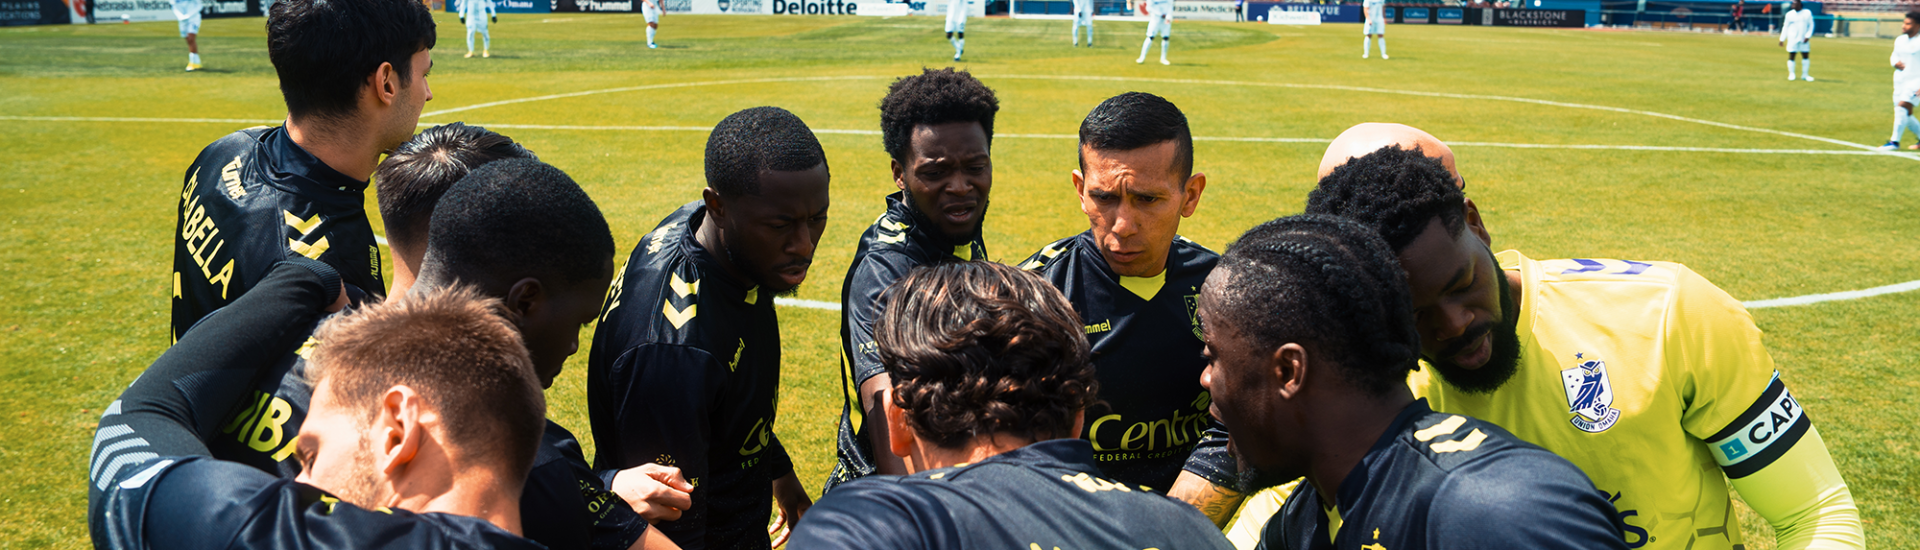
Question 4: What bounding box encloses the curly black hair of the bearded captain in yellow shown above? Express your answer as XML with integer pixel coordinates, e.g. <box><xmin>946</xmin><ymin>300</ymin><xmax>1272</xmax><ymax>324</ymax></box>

<box><xmin>1306</xmin><ymin>146</ymin><xmax>1467</xmax><ymax>254</ymax></box>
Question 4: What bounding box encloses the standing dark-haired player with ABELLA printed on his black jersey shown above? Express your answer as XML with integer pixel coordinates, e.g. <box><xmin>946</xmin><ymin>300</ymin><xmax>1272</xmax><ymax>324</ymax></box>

<box><xmin>173</xmin><ymin>0</ymin><xmax>434</xmax><ymax>338</ymax></box>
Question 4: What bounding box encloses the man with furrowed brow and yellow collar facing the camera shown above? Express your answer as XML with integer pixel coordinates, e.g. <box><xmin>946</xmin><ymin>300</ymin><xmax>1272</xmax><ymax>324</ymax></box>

<box><xmin>1020</xmin><ymin>92</ymin><xmax>1240</xmax><ymax>523</ymax></box>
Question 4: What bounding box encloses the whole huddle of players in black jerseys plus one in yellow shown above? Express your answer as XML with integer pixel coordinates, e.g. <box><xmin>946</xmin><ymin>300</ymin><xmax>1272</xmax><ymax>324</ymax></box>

<box><xmin>88</xmin><ymin>0</ymin><xmax>1864</xmax><ymax>548</ymax></box>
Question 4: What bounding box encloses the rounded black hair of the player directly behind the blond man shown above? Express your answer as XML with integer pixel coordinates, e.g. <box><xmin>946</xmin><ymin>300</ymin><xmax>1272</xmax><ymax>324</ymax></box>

<box><xmin>420</xmin><ymin>158</ymin><xmax>612</xmax><ymax>285</ymax></box>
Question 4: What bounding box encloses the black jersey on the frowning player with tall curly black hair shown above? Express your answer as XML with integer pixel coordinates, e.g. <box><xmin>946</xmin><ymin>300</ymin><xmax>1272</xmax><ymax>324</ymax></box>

<box><xmin>822</xmin><ymin>190</ymin><xmax>987</xmax><ymax>490</ymax></box>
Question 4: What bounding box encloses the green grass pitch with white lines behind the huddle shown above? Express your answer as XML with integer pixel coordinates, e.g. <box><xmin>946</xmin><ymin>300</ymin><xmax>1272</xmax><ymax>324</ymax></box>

<box><xmin>0</xmin><ymin>13</ymin><xmax>1920</xmax><ymax>548</ymax></box>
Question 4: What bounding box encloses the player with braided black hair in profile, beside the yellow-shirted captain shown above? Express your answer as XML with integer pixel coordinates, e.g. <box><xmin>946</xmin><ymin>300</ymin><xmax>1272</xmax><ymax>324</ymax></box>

<box><xmin>1198</xmin><ymin>215</ymin><xmax>1626</xmax><ymax>550</ymax></box>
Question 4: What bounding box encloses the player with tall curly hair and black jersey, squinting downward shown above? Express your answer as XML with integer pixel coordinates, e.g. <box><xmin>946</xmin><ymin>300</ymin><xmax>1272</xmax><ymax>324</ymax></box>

<box><xmin>824</xmin><ymin>67</ymin><xmax>1000</xmax><ymax>490</ymax></box>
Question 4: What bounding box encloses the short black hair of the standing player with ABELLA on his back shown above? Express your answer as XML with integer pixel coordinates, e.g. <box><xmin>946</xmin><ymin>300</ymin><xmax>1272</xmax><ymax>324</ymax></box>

<box><xmin>267</xmin><ymin>0</ymin><xmax>434</xmax><ymax>119</ymax></box>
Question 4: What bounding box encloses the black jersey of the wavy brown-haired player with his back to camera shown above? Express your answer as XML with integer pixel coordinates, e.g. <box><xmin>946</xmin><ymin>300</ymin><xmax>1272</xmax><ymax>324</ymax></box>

<box><xmin>789</xmin><ymin>438</ymin><xmax>1233</xmax><ymax>550</ymax></box>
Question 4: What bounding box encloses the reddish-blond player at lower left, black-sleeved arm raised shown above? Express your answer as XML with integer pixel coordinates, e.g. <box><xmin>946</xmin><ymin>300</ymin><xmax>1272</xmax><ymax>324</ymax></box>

<box><xmin>88</xmin><ymin>256</ymin><xmax>545</xmax><ymax>550</ymax></box>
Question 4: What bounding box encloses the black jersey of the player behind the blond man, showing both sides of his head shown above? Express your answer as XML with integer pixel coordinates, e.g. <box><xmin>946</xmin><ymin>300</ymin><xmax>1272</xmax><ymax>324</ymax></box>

<box><xmin>201</xmin><ymin>323</ymin><xmax>647</xmax><ymax>550</ymax></box>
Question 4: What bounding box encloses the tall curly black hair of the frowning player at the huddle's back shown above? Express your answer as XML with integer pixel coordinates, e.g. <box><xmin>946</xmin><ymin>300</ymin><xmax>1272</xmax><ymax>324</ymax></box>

<box><xmin>879</xmin><ymin>67</ymin><xmax>1000</xmax><ymax>163</ymax></box>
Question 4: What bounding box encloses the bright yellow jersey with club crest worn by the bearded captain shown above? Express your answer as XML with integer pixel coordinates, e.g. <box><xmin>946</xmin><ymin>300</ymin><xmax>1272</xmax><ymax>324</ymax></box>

<box><xmin>1409</xmin><ymin>250</ymin><xmax>1804</xmax><ymax>550</ymax></box>
